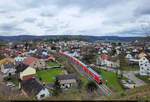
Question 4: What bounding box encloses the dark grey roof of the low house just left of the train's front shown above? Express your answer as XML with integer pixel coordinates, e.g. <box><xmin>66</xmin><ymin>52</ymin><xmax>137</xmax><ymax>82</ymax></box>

<box><xmin>56</xmin><ymin>73</ymin><xmax>77</xmax><ymax>80</ymax></box>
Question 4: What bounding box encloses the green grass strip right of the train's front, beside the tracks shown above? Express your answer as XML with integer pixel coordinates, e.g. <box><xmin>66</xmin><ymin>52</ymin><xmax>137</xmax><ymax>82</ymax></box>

<box><xmin>100</xmin><ymin>69</ymin><xmax>123</xmax><ymax>91</ymax></box>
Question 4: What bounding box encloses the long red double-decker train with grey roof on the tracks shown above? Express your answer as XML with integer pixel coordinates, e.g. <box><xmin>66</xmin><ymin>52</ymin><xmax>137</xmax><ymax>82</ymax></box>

<box><xmin>60</xmin><ymin>52</ymin><xmax>103</xmax><ymax>84</ymax></box>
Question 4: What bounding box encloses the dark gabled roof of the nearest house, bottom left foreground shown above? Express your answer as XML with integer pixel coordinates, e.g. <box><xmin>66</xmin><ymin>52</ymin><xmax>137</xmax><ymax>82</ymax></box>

<box><xmin>21</xmin><ymin>78</ymin><xmax>44</xmax><ymax>95</ymax></box>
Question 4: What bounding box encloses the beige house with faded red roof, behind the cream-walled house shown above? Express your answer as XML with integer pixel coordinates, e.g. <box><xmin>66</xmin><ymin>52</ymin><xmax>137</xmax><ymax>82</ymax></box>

<box><xmin>23</xmin><ymin>56</ymin><xmax>46</xmax><ymax>69</ymax></box>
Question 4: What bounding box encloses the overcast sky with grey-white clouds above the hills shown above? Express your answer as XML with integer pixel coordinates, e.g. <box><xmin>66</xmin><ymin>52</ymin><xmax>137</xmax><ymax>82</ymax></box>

<box><xmin>0</xmin><ymin>0</ymin><xmax>150</xmax><ymax>36</ymax></box>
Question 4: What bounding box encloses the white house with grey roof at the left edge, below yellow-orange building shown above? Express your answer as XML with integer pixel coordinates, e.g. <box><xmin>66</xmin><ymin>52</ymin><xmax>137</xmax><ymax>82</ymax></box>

<box><xmin>1</xmin><ymin>62</ymin><xmax>16</xmax><ymax>74</ymax></box>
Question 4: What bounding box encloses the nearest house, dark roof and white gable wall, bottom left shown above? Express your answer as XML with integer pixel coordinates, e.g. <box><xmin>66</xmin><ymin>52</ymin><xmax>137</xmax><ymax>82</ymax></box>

<box><xmin>21</xmin><ymin>78</ymin><xmax>50</xmax><ymax>100</ymax></box>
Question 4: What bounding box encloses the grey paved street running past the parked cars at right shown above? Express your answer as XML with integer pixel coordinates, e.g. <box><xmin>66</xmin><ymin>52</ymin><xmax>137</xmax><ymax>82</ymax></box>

<box><xmin>97</xmin><ymin>66</ymin><xmax>146</xmax><ymax>86</ymax></box>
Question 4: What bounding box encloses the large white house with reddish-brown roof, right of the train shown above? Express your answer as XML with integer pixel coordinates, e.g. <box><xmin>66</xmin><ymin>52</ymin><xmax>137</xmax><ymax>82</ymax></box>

<box><xmin>97</xmin><ymin>55</ymin><xmax>119</xmax><ymax>68</ymax></box>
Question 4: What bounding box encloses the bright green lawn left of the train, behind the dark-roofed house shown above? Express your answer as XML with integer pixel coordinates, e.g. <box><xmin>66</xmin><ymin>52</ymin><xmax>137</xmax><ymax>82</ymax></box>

<box><xmin>37</xmin><ymin>68</ymin><xmax>62</xmax><ymax>82</ymax></box>
